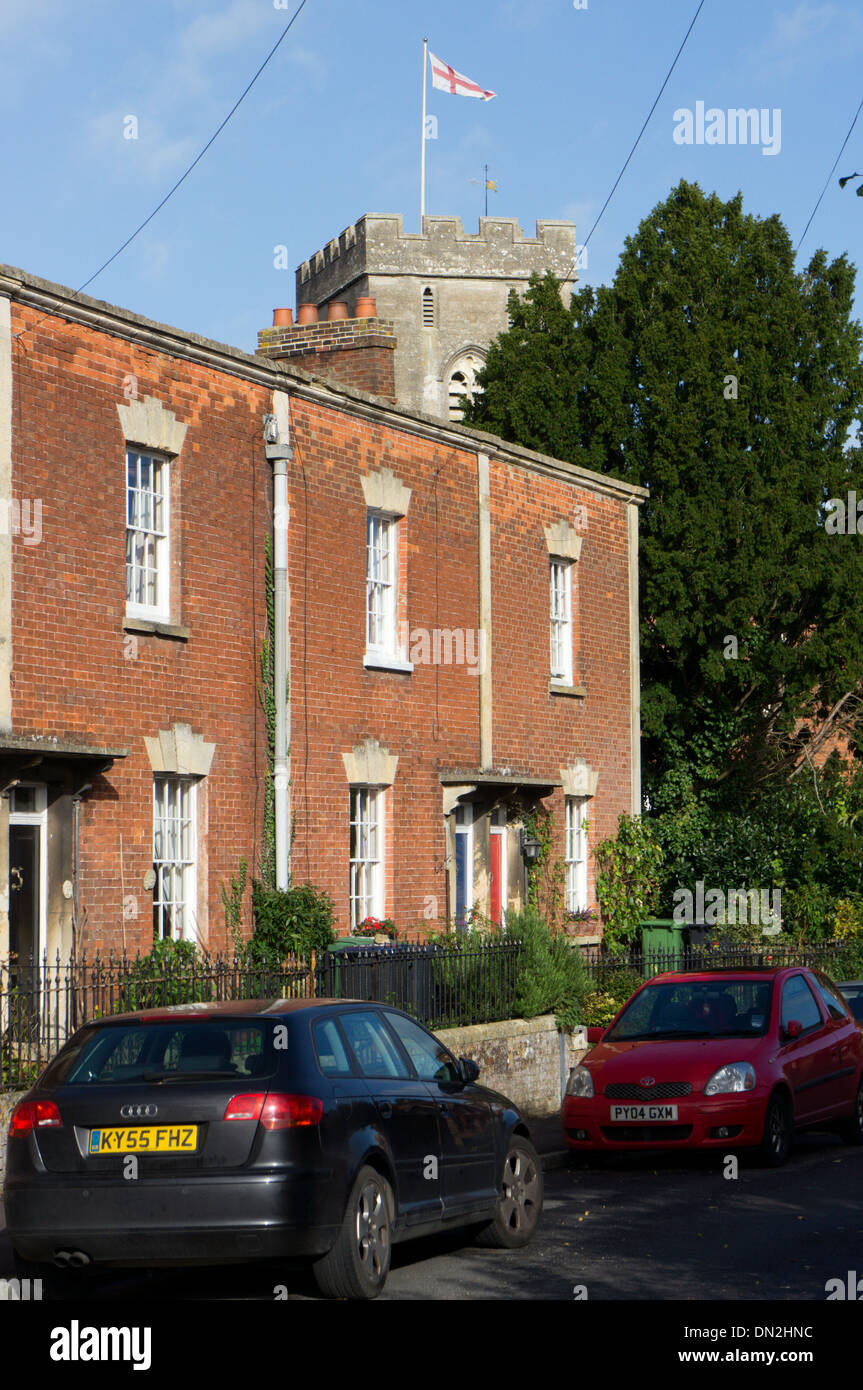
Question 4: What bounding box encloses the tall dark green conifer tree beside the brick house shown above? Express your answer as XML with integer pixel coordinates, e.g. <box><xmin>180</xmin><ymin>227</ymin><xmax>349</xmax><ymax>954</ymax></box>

<box><xmin>466</xmin><ymin>182</ymin><xmax>863</xmax><ymax>809</ymax></box>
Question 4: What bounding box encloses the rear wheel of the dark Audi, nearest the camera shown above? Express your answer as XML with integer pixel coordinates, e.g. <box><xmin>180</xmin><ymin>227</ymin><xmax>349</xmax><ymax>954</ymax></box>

<box><xmin>313</xmin><ymin>1165</ymin><xmax>395</xmax><ymax>1298</ymax></box>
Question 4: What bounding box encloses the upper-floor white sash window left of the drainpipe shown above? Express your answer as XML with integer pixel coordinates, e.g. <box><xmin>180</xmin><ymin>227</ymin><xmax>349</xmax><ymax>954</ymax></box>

<box><xmin>125</xmin><ymin>448</ymin><xmax>171</xmax><ymax>621</ymax></box>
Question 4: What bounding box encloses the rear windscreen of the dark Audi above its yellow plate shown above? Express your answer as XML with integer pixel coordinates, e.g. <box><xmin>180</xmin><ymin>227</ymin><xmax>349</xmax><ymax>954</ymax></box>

<box><xmin>43</xmin><ymin>1019</ymin><xmax>283</xmax><ymax>1086</ymax></box>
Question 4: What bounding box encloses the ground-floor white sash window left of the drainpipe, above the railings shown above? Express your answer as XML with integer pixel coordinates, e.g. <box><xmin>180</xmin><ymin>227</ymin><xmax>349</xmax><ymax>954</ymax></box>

<box><xmin>153</xmin><ymin>773</ymin><xmax>197</xmax><ymax>941</ymax></box>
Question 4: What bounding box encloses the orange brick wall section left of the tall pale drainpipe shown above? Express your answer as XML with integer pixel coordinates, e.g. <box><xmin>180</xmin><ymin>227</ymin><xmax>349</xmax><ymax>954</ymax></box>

<box><xmin>13</xmin><ymin>304</ymin><xmax>272</xmax><ymax>952</ymax></box>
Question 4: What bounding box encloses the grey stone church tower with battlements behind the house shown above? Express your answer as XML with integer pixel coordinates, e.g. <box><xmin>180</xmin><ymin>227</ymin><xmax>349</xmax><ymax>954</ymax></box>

<box><xmin>296</xmin><ymin>213</ymin><xmax>577</xmax><ymax>420</ymax></box>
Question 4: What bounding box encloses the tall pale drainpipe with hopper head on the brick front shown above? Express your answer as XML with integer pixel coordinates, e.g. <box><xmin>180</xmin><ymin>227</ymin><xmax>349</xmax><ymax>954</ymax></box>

<box><xmin>264</xmin><ymin>391</ymin><xmax>293</xmax><ymax>890</ymax></box>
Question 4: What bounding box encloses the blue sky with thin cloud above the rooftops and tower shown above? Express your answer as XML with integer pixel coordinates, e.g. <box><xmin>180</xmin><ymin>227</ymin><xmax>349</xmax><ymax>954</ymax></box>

<box><xmin>0</xmin><ymin>0</ymin><xmax>863</xmax><ymax>350</ymax></box>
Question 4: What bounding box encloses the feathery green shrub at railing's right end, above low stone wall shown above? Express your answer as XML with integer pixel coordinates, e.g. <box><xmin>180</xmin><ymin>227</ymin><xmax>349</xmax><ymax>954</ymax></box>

<box><xmin>506</xmin><ymin>908</ymin><xmax>588</xmax><ymax>1030</ymax></box>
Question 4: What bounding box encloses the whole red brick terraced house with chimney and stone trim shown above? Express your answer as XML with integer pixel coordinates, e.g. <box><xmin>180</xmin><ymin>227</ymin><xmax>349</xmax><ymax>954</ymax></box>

<box><xmin>0</xmin><ymin>267</ymin><xmax>643</xmax><ymax>956</ymax></box>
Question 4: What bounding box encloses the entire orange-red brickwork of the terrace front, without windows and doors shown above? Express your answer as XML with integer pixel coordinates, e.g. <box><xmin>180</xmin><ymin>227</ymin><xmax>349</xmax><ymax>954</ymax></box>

<box><xmin>1</xmin><ymin>265</ymin><xmax>631</xmax><ymax>952</ymax></box>
